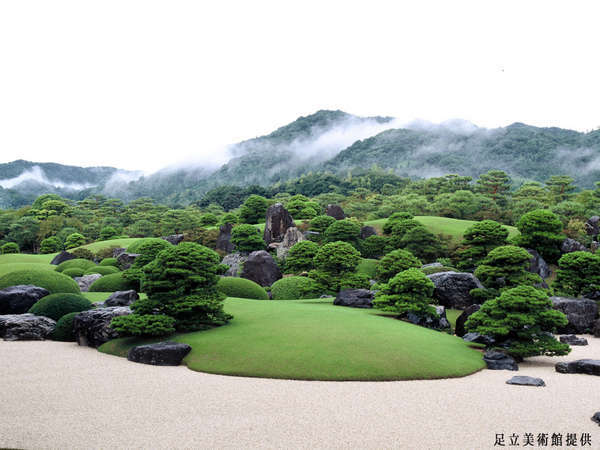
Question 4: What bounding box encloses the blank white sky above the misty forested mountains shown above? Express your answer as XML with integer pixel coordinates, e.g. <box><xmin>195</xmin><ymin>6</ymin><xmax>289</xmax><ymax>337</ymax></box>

<box><xmin>0</xmin><ymin>0</ymin><xmax>600</xmax><ymax>171</ymax></box>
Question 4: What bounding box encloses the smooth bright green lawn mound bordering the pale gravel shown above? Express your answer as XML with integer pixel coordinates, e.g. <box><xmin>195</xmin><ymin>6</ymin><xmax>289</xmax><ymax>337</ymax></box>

<box><xmin>99</xmin><ymin>298</ymin><xmax>484</xmax><ymax>381</ymax></box>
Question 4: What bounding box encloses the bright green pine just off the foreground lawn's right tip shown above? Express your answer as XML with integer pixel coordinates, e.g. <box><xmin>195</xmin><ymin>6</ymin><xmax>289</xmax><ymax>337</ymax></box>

<box><xmin>465</xmin><ymin>286</ymin><xmax>571</xmax><ymax>358</ymax></box>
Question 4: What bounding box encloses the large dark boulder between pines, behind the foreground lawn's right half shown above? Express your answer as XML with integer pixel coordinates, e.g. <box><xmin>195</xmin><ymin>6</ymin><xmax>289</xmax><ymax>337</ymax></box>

<box><xmin>427</xmin><ymin>272</ymin><xmax>483</xmax><ymax>309</ymax></box>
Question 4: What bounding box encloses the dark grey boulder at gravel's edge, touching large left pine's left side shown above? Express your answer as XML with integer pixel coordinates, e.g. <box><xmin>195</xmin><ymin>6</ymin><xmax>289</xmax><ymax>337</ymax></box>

<box><xmin>73</xmin><ymin>306</ymin><xmax>131</xmax><ymax>347</ymax></box>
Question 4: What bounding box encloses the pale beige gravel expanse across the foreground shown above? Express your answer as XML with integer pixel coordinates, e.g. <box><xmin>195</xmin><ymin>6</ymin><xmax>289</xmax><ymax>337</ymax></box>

<box><xmin>0</xmin><ymin>336</ymin><xmax>600</xmax><ymax>449</ymax></box>
